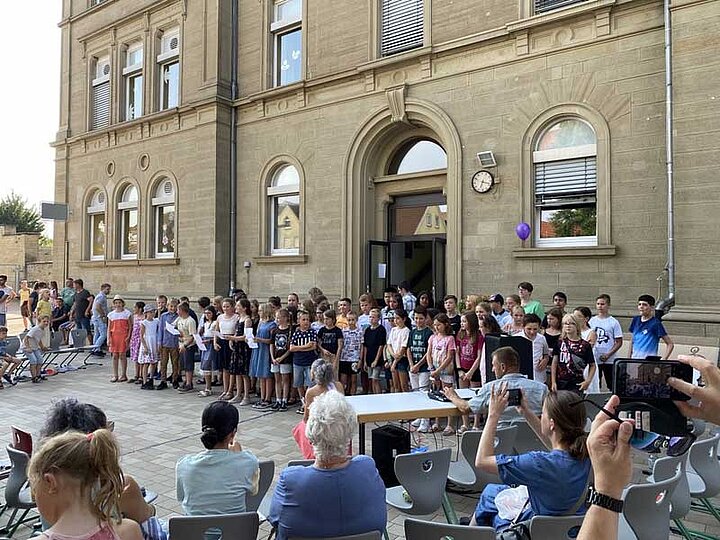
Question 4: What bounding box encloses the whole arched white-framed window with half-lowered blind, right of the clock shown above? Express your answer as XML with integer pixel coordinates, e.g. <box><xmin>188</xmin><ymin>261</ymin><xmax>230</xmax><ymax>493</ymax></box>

<box><xmin>532</xmin><ymin>117</ymin><xmax>598</xmax><ymax>247</ymax></box>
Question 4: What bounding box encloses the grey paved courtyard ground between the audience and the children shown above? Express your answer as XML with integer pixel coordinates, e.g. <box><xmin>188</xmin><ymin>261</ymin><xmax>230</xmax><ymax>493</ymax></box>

<box><xmin>0</xmin><ymin>310</ymin><xmax>720</xmax><ymax>540</ymax></box>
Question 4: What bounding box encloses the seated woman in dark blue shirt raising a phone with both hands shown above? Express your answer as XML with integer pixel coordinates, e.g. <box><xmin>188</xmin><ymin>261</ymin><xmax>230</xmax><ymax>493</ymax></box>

<box><xmin>471</xmin><ymin>385</ymin><xmax>590</xmax><ymax>530</ymax></box>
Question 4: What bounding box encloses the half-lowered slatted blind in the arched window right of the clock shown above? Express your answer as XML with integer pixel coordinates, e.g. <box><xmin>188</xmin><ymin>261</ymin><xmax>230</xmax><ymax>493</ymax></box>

<box><xmin>535</xmin><ymin>157</ymin><xmax>597</xmax><ymax>206</ymax></box>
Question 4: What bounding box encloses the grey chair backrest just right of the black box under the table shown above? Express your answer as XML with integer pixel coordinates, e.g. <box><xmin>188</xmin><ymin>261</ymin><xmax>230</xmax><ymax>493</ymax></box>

<box><xmin>395</xmin><ymin>448</ymin><xmax>452</xmax><ymax>515</ymax></box>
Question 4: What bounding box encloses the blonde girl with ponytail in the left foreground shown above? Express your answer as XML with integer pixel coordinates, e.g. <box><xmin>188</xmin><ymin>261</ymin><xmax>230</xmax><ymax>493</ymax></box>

<box><xmin>28</xmin><ymin>429</ymin><xmax>142</xmax><ymax>540</ymax></box>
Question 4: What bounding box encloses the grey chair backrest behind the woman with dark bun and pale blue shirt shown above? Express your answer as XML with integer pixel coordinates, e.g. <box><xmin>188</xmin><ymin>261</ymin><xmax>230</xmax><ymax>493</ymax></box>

<box><xmin>169</xmin><ymin>512</ymin><xmax>260</xmax><ymax>540</ymax></box>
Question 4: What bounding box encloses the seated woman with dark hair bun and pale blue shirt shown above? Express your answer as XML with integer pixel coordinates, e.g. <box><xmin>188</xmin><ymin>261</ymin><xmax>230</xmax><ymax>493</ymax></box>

<box><xmin>175</xmin><ymin>401</ymin><xmax>260</xmax><ymax>516</ymax></box>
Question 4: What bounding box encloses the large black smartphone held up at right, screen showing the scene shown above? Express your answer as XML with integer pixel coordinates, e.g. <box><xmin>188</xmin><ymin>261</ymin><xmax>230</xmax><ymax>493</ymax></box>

<box><xmin>613</xmin><ymin>358</ymin><xmax>693</xmax><ymax>401</ymax></box>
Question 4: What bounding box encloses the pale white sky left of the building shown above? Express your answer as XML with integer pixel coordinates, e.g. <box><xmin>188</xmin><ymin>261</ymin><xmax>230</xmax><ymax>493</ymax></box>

<box><xmin>0</xmin><ymin>0</ymin><xmax>62</xmax><ymax>236</ymax></box>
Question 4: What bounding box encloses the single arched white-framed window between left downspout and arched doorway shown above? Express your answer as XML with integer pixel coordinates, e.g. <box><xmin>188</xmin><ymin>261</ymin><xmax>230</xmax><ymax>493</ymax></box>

<box><xmin>267</xmin><ymin>165</ymin><xmax>300</xmax><ymax>255</ymax></box>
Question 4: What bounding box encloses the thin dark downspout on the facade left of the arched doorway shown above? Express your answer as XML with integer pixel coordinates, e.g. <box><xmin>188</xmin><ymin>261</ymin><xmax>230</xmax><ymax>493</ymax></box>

<box><xmin>228</xmin><ymin>0</ymin><xmax>238</xmax><ymax>296</ymax></box>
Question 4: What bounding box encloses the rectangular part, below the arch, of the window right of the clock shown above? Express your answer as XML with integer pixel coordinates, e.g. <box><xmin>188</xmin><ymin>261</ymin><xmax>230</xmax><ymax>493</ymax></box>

<box><xmin>535</xmin><ymin>156</ymin><xmax>597</xmax><ymax>247</ymax></box>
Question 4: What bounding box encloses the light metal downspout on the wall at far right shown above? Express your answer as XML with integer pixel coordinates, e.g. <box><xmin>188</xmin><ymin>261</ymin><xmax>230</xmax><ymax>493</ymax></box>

<box><xmin>656</xmin><ymin>0</ymin><xmax>675</xmax><ymax>313</ymax></box>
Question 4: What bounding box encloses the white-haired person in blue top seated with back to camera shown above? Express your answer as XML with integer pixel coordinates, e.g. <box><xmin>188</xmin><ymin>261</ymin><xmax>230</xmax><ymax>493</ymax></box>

<box><xmin>268</xmin><ymin>392</ymin><xmax>387</xmax><ymax>540</ymax></box>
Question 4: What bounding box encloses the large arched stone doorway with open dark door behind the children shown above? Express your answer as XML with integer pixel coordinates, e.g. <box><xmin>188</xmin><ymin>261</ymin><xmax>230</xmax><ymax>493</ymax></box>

<box><xmin>341</xmin><ymin>97</ymin><xmax>462</xmax><ymax>297</ymax></box>
